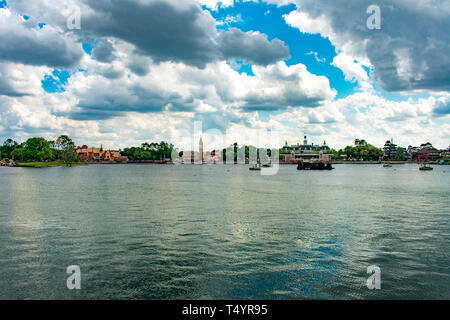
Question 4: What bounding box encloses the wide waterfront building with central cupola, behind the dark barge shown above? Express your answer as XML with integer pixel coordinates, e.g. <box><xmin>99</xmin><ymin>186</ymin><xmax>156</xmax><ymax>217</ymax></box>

<box><xmin>280</xmin><ymin>136</ymin><xmax>331</xmax><ymax>163</ymax></box>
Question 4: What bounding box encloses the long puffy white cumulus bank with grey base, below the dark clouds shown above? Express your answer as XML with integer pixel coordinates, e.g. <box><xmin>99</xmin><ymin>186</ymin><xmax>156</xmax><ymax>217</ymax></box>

<box><xmin>64</xmin><ymin>56</ymin><xmax>335</xmax><ymax>119</ymax></box>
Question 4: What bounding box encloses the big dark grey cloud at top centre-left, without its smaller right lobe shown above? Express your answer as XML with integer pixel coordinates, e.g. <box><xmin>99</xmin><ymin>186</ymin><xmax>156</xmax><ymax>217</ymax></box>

<box><xmin>82</xmin><ymin>0</ymin><xmax>219</xmax><ymax>67</ymax></box>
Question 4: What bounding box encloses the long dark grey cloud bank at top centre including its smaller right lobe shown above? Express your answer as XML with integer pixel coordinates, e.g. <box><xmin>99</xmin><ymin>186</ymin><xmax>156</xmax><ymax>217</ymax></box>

<box><xmin>82</xmin><ymin>0</ymin><xmax>289</xmax><ymax>67</ymax></box>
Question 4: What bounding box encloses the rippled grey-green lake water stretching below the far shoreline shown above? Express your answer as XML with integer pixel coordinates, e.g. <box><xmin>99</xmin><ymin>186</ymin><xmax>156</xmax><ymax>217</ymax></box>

<box><xmin>0</xmin><ymin>165</ymin><xmax>450</xmax><ymax>299</ymax></box>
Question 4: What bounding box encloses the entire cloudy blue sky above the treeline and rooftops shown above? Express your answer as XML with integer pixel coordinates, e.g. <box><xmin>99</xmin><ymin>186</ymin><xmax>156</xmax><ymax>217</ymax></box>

<box><xmin>0</xmin><ymin>0</ymin><xmax>450</xmax><ymax>150</ymax></box>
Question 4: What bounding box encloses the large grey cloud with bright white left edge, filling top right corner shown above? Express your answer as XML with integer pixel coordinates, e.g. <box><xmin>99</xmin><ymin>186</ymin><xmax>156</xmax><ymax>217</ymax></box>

<box><xmin>285</xmin><ymin>0</ymin><xmax>450</xmax><ymax>91</ymax></box>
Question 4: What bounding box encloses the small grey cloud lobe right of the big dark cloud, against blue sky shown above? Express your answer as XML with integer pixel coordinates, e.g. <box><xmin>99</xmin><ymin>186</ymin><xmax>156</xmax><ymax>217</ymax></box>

<box><xmin>219</xmin><ymin>28</ymin><xmax>289</xmax><ymax>66</ymax></box>
